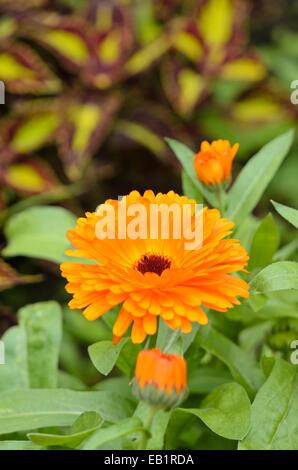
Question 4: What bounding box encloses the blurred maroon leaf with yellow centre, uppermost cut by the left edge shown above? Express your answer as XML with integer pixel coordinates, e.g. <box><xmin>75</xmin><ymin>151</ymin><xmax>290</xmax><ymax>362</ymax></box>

<box><xmin>0</xmin><ymin>43</ymin><xmax>60</xmax><ymax>94</ymax></box>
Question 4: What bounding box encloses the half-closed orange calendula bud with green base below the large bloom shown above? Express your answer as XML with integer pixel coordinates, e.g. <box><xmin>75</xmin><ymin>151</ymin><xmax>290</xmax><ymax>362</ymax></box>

<box><xmin>133</xmin><ymin>349</ymin><xmax>187</xmax><ymax>407</ymax></box>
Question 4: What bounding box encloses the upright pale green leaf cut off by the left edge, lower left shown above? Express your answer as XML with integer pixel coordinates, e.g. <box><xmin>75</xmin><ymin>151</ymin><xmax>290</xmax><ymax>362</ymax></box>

<box><xmin>0</xmin><ymin>326</ymin><xmax>29</xmax><ymax>392</ymax></box>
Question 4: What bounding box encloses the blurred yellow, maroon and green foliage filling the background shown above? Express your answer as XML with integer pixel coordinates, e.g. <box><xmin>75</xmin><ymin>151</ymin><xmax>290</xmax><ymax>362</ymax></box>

<box><xmin>0</xmin><ymin>0</ymin><xmax>298</xmax><ymax>418</ymax></box>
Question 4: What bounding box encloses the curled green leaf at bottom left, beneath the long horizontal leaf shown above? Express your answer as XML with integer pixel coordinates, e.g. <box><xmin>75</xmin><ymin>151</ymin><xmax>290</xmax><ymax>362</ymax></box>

<box><xmin>28</xmin><ymin>411</ymin><xmax>103</xmax><ymax>448</ymax></box>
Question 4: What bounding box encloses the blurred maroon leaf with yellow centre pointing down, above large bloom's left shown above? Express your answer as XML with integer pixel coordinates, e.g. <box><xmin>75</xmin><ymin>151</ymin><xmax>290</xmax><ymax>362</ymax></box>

<box><xmin>57</xmin><ymin>94</ymin><xmax>119</xmax><ymax>179</ymax></box>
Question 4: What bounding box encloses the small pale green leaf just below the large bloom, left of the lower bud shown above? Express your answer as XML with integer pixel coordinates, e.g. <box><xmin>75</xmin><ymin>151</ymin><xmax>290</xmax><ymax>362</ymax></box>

<box><xmin>88</xmin><ymin>338</ymin><xmax>128</xmax><ymax>375</ymax></box>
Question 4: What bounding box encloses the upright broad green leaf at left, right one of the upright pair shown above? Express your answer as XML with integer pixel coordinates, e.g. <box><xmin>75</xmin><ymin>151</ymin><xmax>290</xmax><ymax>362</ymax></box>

<box><xmin>19</xmin><ymin>302</ymin><xmax>62</xmax><ymax>388</ymax></box>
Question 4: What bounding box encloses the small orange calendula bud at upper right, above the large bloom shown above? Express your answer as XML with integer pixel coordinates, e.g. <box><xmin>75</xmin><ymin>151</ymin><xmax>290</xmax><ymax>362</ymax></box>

<box><xmin>194</xmin><ymin>139</ymin><xmax>239</xmax><ymax>185</ymax></box>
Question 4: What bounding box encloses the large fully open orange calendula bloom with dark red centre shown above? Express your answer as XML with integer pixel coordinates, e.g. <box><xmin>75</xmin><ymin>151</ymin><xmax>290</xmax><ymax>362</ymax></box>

<box><xmin>61</xmin><ymin>191</ymin><xmax>248</xmax><ymax>343</ymax></box>
